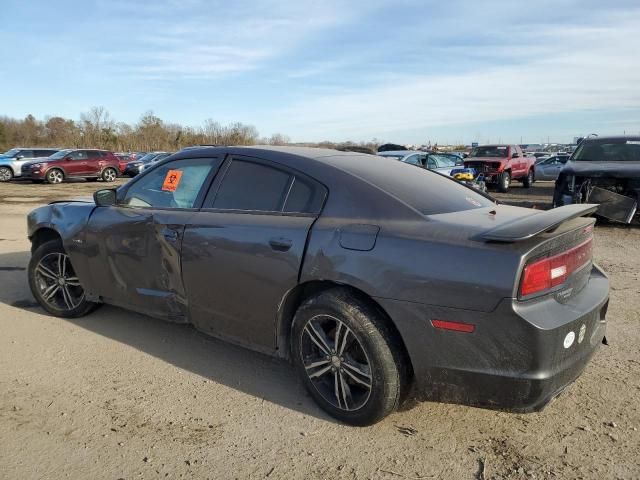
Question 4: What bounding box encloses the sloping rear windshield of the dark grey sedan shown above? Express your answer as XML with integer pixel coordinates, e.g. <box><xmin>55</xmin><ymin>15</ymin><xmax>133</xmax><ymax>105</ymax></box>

<box><xmin>333</xmin><ymin>156</ymin><xmax>495</xmax><ymax>215</ymax></box>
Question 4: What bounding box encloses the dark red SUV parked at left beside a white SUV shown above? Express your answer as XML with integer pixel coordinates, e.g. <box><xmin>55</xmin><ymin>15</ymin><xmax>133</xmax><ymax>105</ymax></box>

<box><xmin>22</xmin><ymin>149</ymin><xmax>120</xmax><ymax>183</ymax></box>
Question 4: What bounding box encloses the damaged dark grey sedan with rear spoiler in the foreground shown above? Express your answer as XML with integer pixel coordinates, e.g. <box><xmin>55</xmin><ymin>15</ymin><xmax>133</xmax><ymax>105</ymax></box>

<box><xmin>28</xmin><ymin>147</ymin><xmax>609</xmax><ymax>425</ymax></box>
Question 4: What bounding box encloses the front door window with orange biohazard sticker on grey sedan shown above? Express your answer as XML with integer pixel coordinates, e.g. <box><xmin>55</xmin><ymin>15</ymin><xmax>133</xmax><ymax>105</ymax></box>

<box><xmin>121</xmin><ymin>158</ymin><xmax>220</xmax><ymax>208</ymax></box>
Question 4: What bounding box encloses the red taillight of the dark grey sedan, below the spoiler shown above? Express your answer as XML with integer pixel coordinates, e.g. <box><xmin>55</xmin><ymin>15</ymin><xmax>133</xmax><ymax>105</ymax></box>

<box><xmin>520</xmin><ymin>238</ymin><xmax>593</xmax><ymax>297</ymax></box>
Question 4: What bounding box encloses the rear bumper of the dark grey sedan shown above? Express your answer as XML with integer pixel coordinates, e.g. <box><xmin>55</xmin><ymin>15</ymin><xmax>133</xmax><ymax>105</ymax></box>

<box><xmin>379</xmin><ymin>266</ymin><xmax>609</xmax><ymax>412</ymax></box>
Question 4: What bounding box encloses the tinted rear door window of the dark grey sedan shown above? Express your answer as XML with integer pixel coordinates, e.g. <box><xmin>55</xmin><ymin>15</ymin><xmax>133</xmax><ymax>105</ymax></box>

<box><xmin>212</xmin><ymin>159</ymin><xmax>326</xmax><ymax>214</ymax></box>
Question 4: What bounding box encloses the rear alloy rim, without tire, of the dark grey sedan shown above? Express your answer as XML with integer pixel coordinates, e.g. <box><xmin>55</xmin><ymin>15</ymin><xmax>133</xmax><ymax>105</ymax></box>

<box><xmin>300</xmin><ymin>315</ymin><xmax>372</xmax><ymax>411</ymax></box>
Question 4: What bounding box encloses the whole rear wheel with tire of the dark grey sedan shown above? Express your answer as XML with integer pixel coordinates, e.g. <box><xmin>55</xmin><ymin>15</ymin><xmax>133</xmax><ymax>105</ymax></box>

<box><xmin>291</xmin><ymin>289</ymin><xmax>408</xmax><ymax>426</ymax></box>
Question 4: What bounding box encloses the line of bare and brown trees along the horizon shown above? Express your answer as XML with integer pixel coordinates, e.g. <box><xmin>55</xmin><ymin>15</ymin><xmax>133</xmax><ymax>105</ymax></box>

<box><xmin>0</xmin><ymin>107</ymin><xmax>378</xmax><ymax>152</ymax></box>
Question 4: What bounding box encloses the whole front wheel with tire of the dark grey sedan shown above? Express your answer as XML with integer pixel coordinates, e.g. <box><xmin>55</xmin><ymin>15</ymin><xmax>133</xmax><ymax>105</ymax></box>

<box><xmin>28</xmin><ymin>240</ymin><xmax>97</xmax><ymax>318</ymax></box>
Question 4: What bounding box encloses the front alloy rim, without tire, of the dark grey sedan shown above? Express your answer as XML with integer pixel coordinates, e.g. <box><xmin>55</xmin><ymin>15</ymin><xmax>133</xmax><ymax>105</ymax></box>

<box><xmin>35</xmin><ymin>253</ymin><xmax>84</xmax><ymax>310</ymax></box>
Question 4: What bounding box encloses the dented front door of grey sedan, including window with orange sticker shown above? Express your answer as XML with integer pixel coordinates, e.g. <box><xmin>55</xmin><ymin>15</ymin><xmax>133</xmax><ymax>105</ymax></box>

<box><xmin>86</xmin><ymin>158</ymin><xmax>219</xmax><ymax>322</ymax></box>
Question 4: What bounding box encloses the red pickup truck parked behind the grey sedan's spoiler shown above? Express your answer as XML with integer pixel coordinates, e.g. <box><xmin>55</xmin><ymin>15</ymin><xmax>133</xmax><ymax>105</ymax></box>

<box><xmin>464</xmin><ymin>145</ymin><xmax>536</xmax><ymax>193</ymax></box>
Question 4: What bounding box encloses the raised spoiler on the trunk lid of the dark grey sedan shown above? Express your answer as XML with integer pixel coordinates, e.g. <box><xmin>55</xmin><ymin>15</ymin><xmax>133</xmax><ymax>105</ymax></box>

<box><xmin>476</xmin><ymin>203</ymin><xmax>598</xmax><ymax>242</ymax></box>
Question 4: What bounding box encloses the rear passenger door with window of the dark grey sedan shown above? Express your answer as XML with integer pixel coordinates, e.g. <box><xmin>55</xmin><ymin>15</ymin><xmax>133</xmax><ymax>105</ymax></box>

<box><xmin>182</xmin><ymin>155</ymin><xmax>327</xmax><ymax>351</ymax></box>
